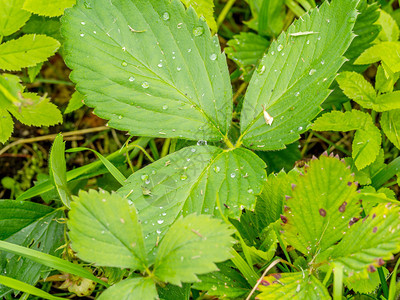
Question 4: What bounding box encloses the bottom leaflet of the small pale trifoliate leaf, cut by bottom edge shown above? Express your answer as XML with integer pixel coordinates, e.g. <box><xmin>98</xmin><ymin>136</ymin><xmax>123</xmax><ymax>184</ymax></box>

<box><xmin>98</xmin><ymin>277</ymin><xmax>158</xmax><ymax>300</ymax></box>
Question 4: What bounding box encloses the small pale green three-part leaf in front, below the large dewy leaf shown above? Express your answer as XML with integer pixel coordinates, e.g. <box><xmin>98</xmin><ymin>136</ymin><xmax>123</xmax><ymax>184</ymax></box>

<box><xmin>68</xmin><ymin>190</ymin><xmax>233</xmax><ymax>299</ymax></box>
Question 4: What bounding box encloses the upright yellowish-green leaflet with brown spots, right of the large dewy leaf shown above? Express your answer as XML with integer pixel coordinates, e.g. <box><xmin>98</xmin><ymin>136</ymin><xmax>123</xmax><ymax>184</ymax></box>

<box><xmin>281</xmin><ymin>156</ymin><xmax>361</xmax><ymax>256</ymax></box>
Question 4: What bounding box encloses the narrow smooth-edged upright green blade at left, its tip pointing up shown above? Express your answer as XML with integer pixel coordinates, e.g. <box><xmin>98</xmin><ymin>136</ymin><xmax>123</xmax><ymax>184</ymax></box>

<box><xmin>49</xmin><ymin>134</ymin><xmax>72</xmax><ymax>208</ymax></box>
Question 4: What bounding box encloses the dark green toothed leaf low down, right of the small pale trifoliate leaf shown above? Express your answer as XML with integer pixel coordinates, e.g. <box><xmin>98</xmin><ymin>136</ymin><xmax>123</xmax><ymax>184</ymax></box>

<box><xmin>192</xmin><ymin>261</ymin><xmax>251</xmax><ymax>298</ymax></box>
